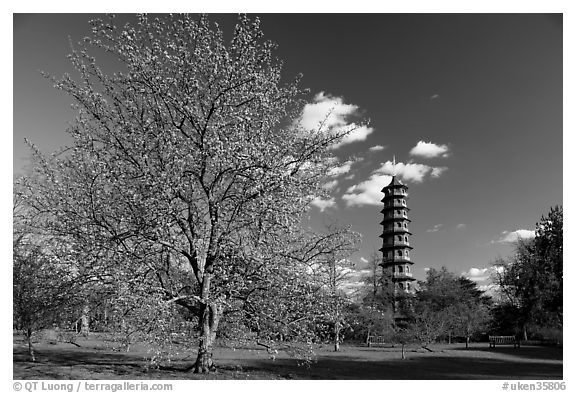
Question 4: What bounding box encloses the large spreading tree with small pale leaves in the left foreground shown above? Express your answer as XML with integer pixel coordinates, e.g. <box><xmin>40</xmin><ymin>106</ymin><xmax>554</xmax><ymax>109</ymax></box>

<box><xmin>19</xmin><ymin>15</ymin><xmax>360</xmax><ymax>372</ymax></box>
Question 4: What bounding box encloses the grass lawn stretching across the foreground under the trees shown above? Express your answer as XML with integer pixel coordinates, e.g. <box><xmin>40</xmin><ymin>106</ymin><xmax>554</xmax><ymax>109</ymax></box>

<box><xmin>13</xmin><ymin>339</ymin><xmax>563</xmax><ymax>380</ymax></box>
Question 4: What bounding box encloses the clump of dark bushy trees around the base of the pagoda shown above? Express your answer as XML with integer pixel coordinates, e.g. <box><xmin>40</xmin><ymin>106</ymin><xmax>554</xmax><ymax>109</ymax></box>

<box><xmin>352</xmin><ymin>255</ymin><xmax>492</xmax><ymax>348</ymax></box>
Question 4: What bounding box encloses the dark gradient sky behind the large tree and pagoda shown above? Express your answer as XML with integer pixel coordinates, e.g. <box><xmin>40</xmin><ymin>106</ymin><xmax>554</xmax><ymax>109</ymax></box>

<box><xmin>13</xmin><ymin>14</ymin><xmax>563</xmax><ymax>284</ymax></box>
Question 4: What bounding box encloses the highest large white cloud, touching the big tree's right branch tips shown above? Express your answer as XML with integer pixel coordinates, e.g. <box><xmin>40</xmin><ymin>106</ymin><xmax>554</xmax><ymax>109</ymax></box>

<box><xmin>299</xmin><ymin>92</ymin><xmax>374</xmax><ymax>149</ymax></box>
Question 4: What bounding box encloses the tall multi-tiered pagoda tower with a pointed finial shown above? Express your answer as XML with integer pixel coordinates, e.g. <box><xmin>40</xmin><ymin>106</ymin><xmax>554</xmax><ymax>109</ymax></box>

<box><xmin>380</xmin><ymin>160</ymin><xmax>416</xmax><ymax>312</ymax></box>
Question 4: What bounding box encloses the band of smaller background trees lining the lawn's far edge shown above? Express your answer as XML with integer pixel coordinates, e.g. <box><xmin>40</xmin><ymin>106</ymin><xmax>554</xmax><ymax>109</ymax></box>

<box><xmin>14</xmin><ymin>193</ymin><xmax>562</xmax><ymax>363</ymax></box>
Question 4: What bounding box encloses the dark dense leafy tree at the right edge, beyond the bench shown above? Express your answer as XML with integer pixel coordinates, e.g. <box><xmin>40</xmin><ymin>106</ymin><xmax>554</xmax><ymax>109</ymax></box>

<box><xmin>495</xmin><ymin>206</ymin><xmax>563</xmax><ymax>339</ymax></box>
